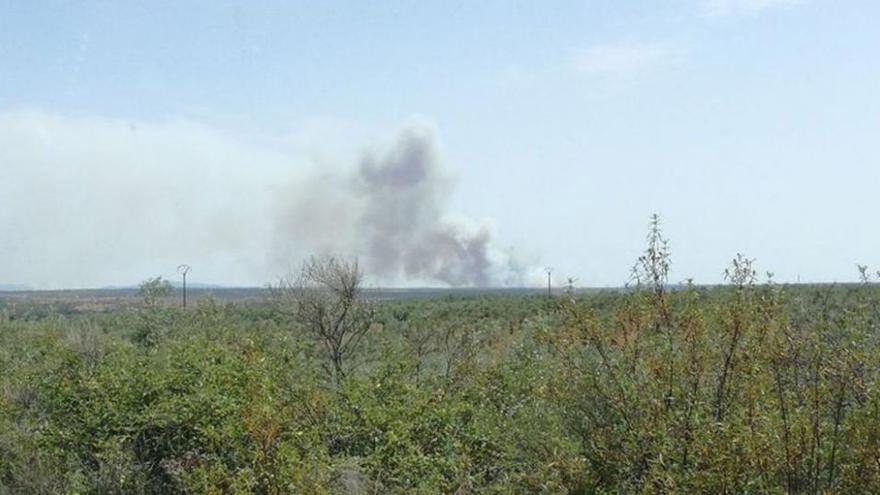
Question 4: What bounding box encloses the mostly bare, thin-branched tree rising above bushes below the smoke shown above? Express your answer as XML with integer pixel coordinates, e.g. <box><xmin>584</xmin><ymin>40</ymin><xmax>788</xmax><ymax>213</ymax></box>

<box><xmin>276</xmin><ymin>256</ymin><xmax>373</xmax><ymax>379</ymax></box>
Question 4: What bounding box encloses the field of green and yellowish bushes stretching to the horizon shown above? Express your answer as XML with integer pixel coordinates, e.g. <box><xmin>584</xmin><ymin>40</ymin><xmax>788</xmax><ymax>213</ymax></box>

<box><xmin>0</xmin><ymin>234</ymin><xmax>880</xmax><ymax>494</ymax></box>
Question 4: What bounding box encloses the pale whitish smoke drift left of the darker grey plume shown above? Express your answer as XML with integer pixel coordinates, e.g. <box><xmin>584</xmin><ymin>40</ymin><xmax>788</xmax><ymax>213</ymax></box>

<box><xmin>0</xmin><ymin>108</ymin><xmax>287</xmax><ymax>288</ymax></box>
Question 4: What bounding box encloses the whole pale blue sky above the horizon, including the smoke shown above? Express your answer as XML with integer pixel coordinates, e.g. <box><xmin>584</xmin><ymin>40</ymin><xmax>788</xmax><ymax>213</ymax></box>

<box><xmin>0</xmin><ymin>0</ymin><xmax>880</xmax><ymax>289</ymax></box>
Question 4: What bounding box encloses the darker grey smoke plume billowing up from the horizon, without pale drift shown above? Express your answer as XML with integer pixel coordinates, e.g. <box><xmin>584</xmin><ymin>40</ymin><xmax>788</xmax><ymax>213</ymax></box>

<box><xmin>281</xmin><ymin>125</ymin><xmax>523</xmax><ymax>287</ymax></box>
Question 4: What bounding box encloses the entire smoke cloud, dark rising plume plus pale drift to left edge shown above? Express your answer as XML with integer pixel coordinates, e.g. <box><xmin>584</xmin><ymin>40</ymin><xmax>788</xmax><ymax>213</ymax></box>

<box><xmin>0</xmin><ymin>111</ymin><xmax>524</xmax><ymax>288</ymax></box>
